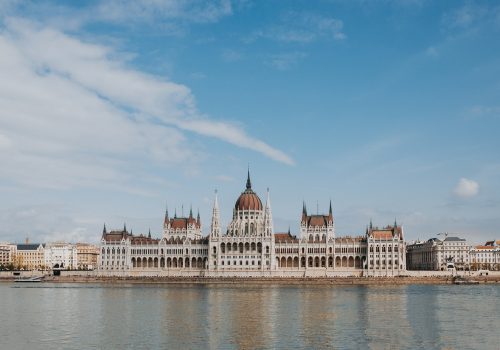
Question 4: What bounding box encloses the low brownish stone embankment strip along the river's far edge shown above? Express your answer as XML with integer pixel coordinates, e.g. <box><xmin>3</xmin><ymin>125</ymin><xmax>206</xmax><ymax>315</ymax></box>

<box><xmin>0</xmin><ymin>276</ymin><xmax>500</xmax><ymax>286</ymax></box>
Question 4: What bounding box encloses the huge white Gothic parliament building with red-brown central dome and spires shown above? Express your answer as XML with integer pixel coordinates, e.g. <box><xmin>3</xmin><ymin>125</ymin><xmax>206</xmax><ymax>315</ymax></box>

<box><xmin>98</xmin><ymin>174</ymin><xmax>406</xmax><ymax>277</ymax></box>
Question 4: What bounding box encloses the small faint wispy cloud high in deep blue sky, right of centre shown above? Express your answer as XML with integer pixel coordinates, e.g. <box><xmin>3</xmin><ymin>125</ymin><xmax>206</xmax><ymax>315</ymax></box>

<box><xmin>246</xmin><ymin>12</ymin><xmax>346</xmax><ymax>43</ymax></box>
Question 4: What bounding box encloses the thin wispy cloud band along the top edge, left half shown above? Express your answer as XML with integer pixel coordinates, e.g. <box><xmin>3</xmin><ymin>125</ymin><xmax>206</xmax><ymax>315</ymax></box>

<box><xmin>0</xmin><ymin>0</ymin><xmax>233</xmax><ymax>35</ymax></box>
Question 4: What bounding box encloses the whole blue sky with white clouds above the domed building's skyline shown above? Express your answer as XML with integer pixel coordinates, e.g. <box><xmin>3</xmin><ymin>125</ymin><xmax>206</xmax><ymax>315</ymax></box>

<box><xmin>0</xmin><ymin>0</ymin><xmax>500</xmax><ymax>243</ymax></box>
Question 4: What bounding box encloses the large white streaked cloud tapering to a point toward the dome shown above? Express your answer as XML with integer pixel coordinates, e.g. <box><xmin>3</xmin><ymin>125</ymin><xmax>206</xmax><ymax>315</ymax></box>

<box><xmin>0</xmin><ymin>19</ymin><xmax>293</xmax><ymax>191</ymax></box>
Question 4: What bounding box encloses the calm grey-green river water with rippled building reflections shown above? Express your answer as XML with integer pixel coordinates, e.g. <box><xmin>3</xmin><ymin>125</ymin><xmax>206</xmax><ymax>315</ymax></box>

<box><xmin>0</xmin><ymin>283</ymin><xmax>500</xmax><ymax>349</ymax></box>
